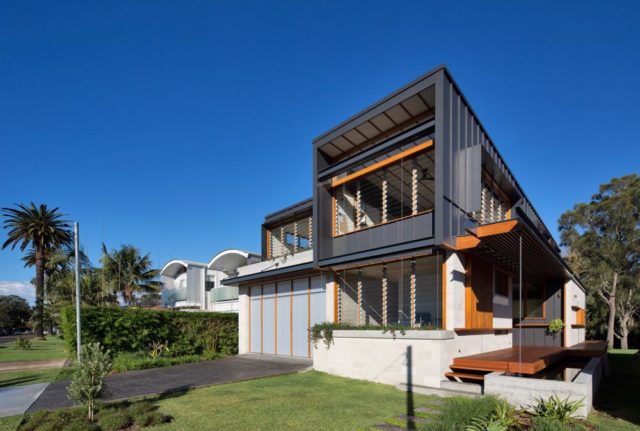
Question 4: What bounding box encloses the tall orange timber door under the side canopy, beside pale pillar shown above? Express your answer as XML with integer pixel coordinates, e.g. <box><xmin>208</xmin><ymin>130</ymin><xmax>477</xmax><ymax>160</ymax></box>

<box><xmin>465</xmin><ymin>256</ymin><xmax>493</xmax><ymax>329</ymax></box>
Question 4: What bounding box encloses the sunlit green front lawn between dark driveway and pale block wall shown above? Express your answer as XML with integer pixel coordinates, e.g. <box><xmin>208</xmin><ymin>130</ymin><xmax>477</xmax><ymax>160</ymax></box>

<box><xmin>148</xmin><ymin>371</ymin><xmax>430</xmax><ymax>431</ymax></box>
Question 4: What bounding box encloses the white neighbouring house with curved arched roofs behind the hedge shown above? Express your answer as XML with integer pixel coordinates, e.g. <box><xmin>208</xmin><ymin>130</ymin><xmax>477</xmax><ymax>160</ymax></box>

<box><xmin>160</xmin><ymin>250</ymin><xmax>259</xmax><ymax>312</ymax></box>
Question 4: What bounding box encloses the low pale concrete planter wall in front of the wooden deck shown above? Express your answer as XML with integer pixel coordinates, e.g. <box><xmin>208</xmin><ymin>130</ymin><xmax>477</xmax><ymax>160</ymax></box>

<box><xmin>484</xmin><ymin>357</ymin><xmax>604</xmax><ymax>417</ymax></box>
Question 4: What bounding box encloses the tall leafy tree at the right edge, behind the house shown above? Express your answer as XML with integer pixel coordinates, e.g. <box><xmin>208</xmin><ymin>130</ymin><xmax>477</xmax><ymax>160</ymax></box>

<box><xmin>559</xmin><ymin>174</ymin><xmax>640</xmax><ymax>347</ymax></box>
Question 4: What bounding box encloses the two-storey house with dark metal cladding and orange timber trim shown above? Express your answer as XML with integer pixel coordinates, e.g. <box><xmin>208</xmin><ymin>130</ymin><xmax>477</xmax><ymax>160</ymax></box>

<box><xmin>226</xmin><ymin>66</ymin><xmax>604</xmax><ymax>416</ymax></box>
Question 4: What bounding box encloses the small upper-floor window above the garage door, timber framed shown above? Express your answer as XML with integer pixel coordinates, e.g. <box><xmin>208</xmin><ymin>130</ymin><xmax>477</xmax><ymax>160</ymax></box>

<box><xmin>267</xmin><ymin>217</ymin><xmax>312</xmax><ymax>259</ymax></box>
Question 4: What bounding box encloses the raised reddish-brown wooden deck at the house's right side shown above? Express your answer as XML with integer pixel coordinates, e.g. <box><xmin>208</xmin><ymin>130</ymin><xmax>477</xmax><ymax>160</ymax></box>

<box><xmin>451</xmin><ymin>341</ymin><xmax>607</xmax><ymax>374</ymax></box>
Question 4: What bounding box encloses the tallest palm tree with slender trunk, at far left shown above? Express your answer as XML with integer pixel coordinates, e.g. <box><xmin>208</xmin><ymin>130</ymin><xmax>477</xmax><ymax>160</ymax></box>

<box><xmin>2</xmin><ymin>202</ymin><xmax>73</xmax><ymax>337</ymax></box>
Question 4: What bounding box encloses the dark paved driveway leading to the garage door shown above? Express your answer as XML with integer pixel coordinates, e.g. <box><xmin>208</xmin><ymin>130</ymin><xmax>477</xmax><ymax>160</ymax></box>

<box><xmin>28</xmin><ymin>354</ymin><xmax>312</xmax><ymax>413</ymax></box>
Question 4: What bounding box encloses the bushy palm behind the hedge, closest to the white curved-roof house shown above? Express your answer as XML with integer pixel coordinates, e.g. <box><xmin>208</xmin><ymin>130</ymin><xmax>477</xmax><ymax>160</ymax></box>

<box><xmin>101</xmin><ymin>243</ymin><xmax>162</xmax><ymax>305</ymax></box>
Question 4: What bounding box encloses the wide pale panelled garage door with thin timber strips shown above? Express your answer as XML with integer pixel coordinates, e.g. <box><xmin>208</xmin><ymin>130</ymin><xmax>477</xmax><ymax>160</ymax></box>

<box><xmin>249</xmin><ymin>276</ymin><xmax>326</xmax><ymax>357</ymax></box>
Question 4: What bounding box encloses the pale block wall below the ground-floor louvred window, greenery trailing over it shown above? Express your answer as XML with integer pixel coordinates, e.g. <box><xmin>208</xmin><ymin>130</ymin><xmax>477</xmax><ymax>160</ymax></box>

<box><xmin>313</xmin><ymin>330</ymin><xmax>511</xmax><ymax>388</ymax></box>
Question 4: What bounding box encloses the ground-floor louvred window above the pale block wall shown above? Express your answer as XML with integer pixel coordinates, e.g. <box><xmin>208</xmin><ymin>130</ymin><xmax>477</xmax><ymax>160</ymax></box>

<box><xmin>338</xmin><ymin>256</ymin><xmax>442</xmax><ymax>328</ymax></box>
